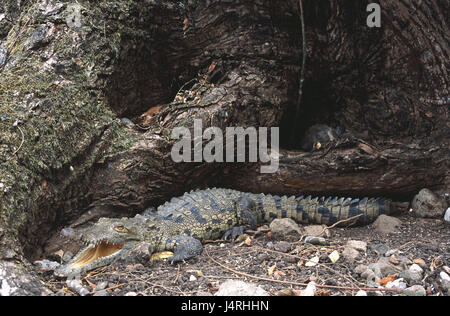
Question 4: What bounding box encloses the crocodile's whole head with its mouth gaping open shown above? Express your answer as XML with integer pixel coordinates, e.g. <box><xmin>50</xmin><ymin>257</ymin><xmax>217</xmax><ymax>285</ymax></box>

<box><xmin>55</xmin><ymin>217</ymin><xmax>142</xmax><ymax>277</ymax></box>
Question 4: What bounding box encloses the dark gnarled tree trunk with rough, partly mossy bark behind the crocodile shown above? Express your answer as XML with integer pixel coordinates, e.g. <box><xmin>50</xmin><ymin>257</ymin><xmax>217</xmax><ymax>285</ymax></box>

<box><xmin>0</xmin><ymin>0</ymin><xmax>450</xmax><ymax>294</ymax></box>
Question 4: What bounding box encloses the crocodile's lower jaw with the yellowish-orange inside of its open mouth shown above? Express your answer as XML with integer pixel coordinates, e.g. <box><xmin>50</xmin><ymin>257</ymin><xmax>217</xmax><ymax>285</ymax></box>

<box><xmin>55</xmin><ymin>240</ymin><xmax>128</xmax><ymax>277</ymax></box>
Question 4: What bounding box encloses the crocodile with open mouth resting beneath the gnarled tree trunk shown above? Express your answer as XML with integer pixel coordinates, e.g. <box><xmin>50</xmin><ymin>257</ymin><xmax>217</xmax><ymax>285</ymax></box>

<box><xmin>55</xmin><ymin>188</ymin><xmax>391</xmax><ymax>277</ymax></box>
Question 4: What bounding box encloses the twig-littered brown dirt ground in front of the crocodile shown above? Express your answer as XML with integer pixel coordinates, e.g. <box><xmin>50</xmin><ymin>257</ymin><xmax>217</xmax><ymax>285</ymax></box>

<box><xmin>43</xmin><ymin>215</ymin><xmax>450</xmax><ymax>296</ymax></box>
